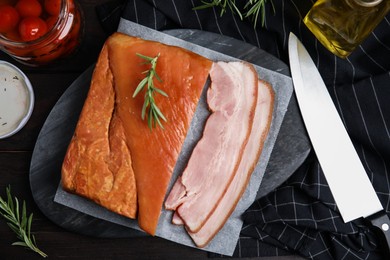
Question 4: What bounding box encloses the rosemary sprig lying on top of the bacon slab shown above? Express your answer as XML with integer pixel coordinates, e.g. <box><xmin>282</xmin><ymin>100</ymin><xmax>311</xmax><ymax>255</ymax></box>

<box><xmin>133</xmin><ymin>53</ymin><xmax>168</xmax><ymax>129</ymax></box>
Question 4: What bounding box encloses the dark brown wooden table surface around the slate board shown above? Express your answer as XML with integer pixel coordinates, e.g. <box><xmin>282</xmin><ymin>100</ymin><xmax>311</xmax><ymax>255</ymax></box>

<box><xmin>0</xmin><ymin>0</ymin><xmax>304</xmax><ymax>259</ymax></box>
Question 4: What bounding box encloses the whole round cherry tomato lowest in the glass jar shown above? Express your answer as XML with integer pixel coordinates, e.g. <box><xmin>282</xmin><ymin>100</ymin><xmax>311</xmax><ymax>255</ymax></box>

<box><xmin>19</xmin><ymin>16</ymin><xmax>47</xmax><ymax>41</ymax></box>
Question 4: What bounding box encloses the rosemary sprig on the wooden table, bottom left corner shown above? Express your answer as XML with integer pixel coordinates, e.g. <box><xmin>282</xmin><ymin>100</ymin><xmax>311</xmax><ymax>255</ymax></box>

<box><xmin>0</xmin><ymin>187</ymin><xmax>47</xmax><ymax>257</ymax></box>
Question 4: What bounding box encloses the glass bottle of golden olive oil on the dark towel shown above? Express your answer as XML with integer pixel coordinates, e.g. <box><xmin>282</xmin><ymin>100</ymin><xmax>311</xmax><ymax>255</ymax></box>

<box><xmin>303</xmin><ymin>0</ymin><xmax>390</xmax><ymax>58</ymax></box>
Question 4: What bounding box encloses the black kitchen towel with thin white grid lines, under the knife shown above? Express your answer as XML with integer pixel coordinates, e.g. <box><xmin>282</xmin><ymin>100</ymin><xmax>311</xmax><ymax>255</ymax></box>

<box><xmin>97</xmin><ymin>0</ymin><xmax>390</xmax><ymax>259</ymax></box>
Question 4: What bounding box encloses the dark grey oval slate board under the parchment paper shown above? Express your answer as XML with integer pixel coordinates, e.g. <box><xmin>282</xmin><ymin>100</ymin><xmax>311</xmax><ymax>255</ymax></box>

<box><xmin>30</xmin><ymin>30</ymin><xmax>310</xmax><ymax>238</ymax></box>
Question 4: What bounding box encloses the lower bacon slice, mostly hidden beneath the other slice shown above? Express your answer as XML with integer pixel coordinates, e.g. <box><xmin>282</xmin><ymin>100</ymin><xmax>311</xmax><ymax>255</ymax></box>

<box><xmin>188</xmin><ymin>80</ymin><xmax>274</xmax><ymax>247</ymax></box>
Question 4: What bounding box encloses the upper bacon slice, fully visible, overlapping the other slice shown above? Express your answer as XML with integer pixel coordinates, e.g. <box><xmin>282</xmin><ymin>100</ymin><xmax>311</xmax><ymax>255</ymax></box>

<box><xmin>165</xmin><ymin>62</ymin><xmax>258</xmax><ymax>232</ymax></box>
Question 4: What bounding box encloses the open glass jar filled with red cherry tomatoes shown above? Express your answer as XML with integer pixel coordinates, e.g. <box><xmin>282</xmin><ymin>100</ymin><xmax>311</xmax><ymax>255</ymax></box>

<box><xmin>0</xmin><ymin>0</ymin><xmax>84</xmax><ymax>66</ymax></box>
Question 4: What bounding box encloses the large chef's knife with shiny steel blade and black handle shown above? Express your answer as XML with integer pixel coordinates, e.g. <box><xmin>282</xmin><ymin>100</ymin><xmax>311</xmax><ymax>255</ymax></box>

<box><xmin>288</xmin><ymin>33</ymin><xmax>390</xmax><ymax>259</ymax></box>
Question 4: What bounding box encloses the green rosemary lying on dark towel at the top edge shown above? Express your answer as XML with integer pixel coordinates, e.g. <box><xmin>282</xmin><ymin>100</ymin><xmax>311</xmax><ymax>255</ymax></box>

<box><xmin>193</xmin><ymin>0</ymin><xmax>275</xmax><ymax>29</ymax></box>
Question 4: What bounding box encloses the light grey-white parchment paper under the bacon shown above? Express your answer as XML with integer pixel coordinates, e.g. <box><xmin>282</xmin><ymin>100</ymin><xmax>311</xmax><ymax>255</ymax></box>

<box><xmin>54</xmin><ymin>19</ymin><xmax>293</xmax><ymax>256</ymax></box>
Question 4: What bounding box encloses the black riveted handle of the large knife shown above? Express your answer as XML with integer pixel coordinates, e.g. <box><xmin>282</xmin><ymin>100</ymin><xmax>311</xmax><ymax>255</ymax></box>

<box><xmin>367</xmin><ymin>211</ymin><xmax>390</xmax><ymax>259</ymax></box>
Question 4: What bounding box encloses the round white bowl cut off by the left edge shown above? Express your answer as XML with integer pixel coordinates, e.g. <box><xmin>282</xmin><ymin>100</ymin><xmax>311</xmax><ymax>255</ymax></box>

<box><xmin>0</xmin><ymin>60</ymin><xmax>35</xmax><ymax>139</ymax></box>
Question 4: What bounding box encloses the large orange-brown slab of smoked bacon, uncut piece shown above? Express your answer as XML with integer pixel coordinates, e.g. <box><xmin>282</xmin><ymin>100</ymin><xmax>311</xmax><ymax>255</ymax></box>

<box><xmin>62</xmin><ymin>33</ymin><xmax>212</xmax><ymax>235</ymax></box>
